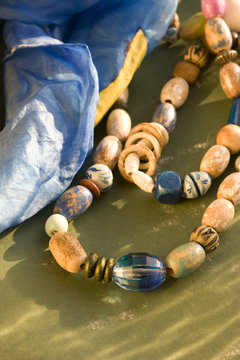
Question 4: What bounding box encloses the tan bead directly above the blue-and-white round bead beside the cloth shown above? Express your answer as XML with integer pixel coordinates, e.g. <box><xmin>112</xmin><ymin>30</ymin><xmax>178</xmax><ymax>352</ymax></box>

<box><xmin>93</xmin><ymin>135</ymin><xmax>122</xmax><ymax>170</ymax></box>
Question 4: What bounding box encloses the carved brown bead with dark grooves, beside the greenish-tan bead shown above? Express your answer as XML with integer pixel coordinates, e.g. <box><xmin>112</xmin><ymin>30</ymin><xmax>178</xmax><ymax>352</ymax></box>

<box><xmin>190</xmin><ymin>225</ymin><xmax>219</xmax><ymax>253</ymax></box>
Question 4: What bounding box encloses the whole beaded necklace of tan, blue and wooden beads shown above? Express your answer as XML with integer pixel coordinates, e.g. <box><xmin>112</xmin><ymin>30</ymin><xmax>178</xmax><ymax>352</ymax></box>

<box><xmin>45</xmin><ymin>1</ymin><xmax>240</xmax><ymax>291</ymax></box>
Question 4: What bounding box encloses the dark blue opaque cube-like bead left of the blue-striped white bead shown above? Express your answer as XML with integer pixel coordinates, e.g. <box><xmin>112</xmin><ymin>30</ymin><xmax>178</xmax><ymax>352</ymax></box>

<box><xmin>154</xmin><ymin>171</ymin><xmax>182</xmax><ymax>204</ymax></box>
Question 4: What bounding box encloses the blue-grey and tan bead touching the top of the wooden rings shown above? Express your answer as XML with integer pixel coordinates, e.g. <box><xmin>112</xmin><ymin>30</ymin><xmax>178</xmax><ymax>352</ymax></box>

<box><xmin>152</xmin><ymin>103</ymin><xmax>177</xmax><ymax>133</ymax></box>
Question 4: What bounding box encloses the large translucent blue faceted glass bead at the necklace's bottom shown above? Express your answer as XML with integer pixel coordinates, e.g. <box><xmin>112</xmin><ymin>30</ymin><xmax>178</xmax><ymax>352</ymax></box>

<box><xmin>113</xmin><ymin>252</ymin><xmax>166</xmax><ymax>291</ymax></box>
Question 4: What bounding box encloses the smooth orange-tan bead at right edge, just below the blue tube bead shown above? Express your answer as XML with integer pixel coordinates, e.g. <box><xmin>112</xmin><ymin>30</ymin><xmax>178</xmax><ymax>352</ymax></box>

<box><xmin>216</xmin><ymin>124</ymin><xmax>240</xmax><ymax>155</ymax></box>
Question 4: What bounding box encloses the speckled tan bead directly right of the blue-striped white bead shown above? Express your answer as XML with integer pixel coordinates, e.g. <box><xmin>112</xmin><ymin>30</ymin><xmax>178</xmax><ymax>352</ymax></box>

<box><xmin>200</xmin><ymin>145</ymin><xmax>230</xmax><ymax>179</ymax></box>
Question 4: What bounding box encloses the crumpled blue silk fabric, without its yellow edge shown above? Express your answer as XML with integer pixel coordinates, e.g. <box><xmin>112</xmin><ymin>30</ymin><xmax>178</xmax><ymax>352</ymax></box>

<box><xmin>0</xmin><ymin>0</ymin><xmax>177</xmax><ymax>232</ymax></box>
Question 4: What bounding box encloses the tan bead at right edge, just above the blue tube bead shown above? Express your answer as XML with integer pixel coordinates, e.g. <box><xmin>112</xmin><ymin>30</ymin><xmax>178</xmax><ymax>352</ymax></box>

<box><xmin>219</xmin><ymin>61</ymin><xmax>240</xmax><ymax>99</ymax></box>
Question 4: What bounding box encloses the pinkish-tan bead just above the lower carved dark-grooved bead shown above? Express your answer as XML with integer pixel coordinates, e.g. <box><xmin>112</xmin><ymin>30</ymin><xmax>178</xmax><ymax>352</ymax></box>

<box><xmin>202</xmin><ymin>199</ymin><xmax>235</xmax><ymax>232</ymax></box>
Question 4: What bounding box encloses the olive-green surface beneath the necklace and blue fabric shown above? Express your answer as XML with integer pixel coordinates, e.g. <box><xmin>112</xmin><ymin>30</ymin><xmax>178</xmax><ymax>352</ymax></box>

<box><xmin>0</xmin><ymin>0</ymin><xmax>240</xmax><ymax>360</ymax></box>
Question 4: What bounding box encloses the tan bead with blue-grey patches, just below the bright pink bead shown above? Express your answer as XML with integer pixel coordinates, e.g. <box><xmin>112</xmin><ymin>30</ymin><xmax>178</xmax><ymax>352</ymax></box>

<box><xmin>205</xmin><ymin>17</ymin><xmax>232</xmax><ymax>54</ymax></box>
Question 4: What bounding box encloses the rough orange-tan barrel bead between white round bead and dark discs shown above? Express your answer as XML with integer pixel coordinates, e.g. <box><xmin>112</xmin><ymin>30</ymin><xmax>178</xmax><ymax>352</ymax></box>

<box><xmin>49</xmin><ymin>232</ymin><xmax>87</xmax><ymax>273</ymax></box>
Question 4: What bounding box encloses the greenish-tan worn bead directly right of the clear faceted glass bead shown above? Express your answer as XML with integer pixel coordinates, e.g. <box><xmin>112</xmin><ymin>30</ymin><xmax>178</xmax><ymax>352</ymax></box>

<box><xmin>165</xmin><ymin>242</ymin><xmax>206</xmax><ymax>278</ymax></box>
